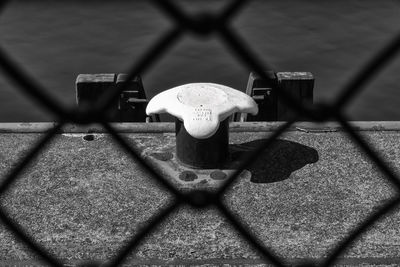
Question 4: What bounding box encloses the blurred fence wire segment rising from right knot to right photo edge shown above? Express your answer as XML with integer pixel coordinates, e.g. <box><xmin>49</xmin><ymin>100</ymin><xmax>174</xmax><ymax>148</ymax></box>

<box><xmin>334</xmin><ymin>33</ymin><xmax>400</xmax><ymax>109</ymax></box>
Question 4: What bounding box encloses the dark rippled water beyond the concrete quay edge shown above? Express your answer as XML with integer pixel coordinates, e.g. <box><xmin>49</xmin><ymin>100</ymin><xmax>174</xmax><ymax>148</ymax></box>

<box><xmin>0</xmin><ymin>0</ymin><xmax>400</xmax><ymax>122</ymax></box>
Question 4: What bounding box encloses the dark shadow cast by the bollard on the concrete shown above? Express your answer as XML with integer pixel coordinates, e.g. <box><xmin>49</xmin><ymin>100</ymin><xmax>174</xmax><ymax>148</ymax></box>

<box><xmin>229</xmin><ymin>139</ymin><xmax>319</xmax><ymax>183</ymax></box>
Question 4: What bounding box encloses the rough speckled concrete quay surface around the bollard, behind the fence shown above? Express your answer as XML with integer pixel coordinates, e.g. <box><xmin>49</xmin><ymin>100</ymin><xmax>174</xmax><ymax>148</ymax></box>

<box><xmin>0</xmin><ymin>131</ymin><xmax>400</xmax><ymax>266</ymax></box>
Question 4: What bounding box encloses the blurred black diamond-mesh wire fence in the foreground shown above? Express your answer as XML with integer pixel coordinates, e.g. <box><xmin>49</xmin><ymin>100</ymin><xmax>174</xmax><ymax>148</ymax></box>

<box><xmin>0</xmin><ymin>0</ymin><xmax>400</xmax><ymax>266</ymax></box>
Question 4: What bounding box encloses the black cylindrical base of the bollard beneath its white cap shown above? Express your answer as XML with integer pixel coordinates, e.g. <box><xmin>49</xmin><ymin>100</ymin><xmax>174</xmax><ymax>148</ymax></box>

<box><xmin>175</xmin><ymin>118</ymin><xmax>229</xmax><ymax>169</ymax></box>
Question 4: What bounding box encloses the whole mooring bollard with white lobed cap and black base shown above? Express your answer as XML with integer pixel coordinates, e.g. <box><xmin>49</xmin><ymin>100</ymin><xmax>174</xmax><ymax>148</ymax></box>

<box><xmin>146</xmin><ymin>83</ymin><xmax>258</xmax><ymax>169</ymax></box>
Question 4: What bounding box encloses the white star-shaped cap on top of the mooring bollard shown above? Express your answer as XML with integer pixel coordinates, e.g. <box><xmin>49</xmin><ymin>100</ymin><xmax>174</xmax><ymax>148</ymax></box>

<box><xmin>146</xmin><ymin>83</ymin><xmax>258</xmax><ymax>139</ymax></box>
